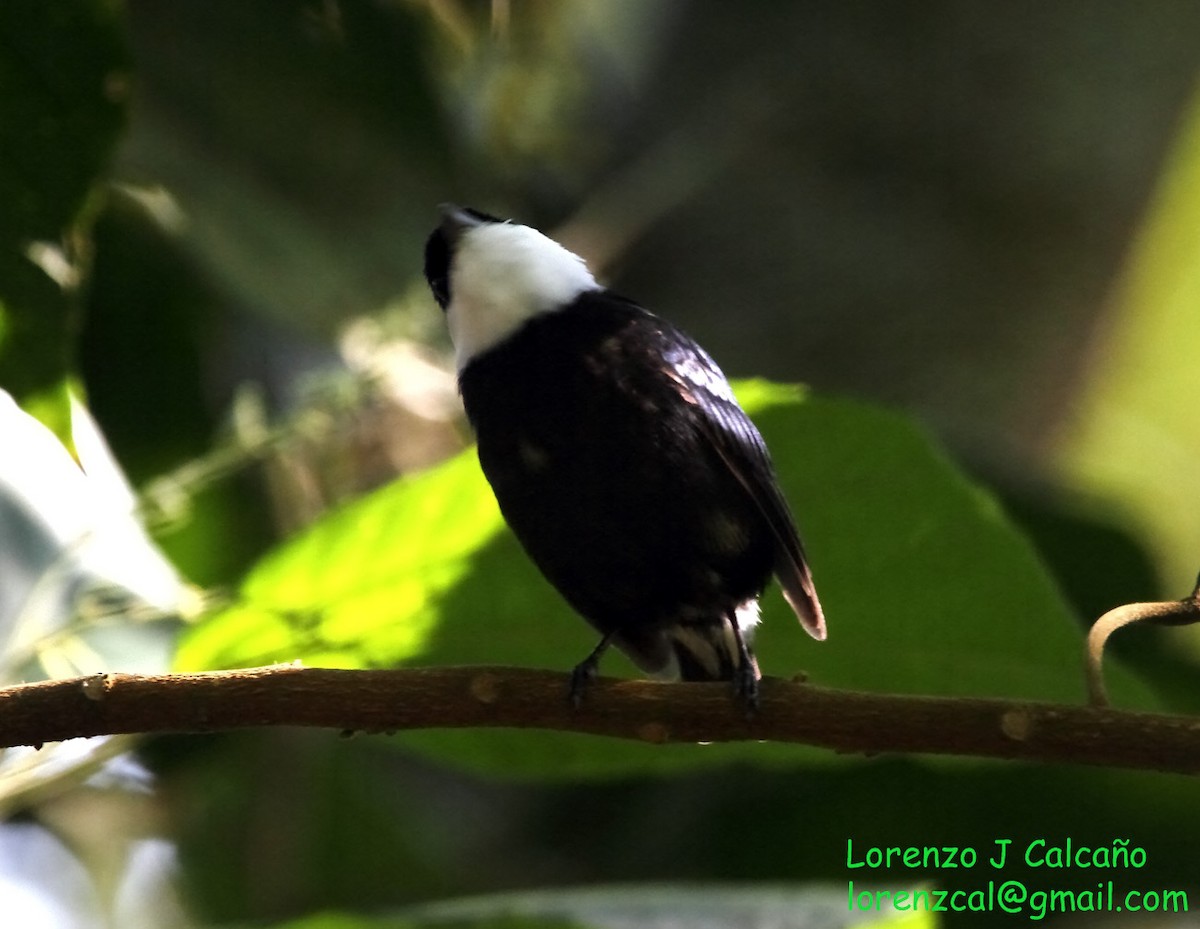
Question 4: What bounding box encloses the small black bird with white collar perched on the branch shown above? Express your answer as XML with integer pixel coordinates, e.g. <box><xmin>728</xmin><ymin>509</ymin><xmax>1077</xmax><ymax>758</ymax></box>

<box><xmin>425</xmin><ymin>205</ymin><xmax>826</xmax><ymax>707</ymax></box>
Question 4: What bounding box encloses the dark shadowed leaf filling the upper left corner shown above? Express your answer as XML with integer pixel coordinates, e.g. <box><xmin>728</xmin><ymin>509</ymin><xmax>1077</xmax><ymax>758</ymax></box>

<box><xmin>0</xmin><ymin>0</ymin><xmax>130</xmax><ymax>442</ymax></box>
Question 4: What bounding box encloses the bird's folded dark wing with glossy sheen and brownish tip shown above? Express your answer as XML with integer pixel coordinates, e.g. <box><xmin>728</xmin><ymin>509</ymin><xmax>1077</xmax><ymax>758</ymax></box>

<box><xmin>664</xmin><ymin>324</ymin><xmax>826</xmax><ymax>640</ymax></box>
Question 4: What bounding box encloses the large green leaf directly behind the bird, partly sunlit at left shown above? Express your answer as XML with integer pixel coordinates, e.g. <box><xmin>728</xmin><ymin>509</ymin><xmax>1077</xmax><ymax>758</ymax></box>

<box><xmin>179</xmin><ymin>382</ymin><xmax>1151</xmax><ymax>777</ymax></box>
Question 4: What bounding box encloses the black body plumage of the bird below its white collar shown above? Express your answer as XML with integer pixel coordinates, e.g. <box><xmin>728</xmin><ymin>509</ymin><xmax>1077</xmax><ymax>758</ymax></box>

<box><xmin>460</xmin><ymin>290</ymin><xmax>803</xmax><ymax>676</ymax></box>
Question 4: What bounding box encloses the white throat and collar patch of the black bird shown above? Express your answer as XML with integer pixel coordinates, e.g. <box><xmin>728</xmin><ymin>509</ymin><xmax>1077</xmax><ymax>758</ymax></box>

<box><xmin>446</xmin><ymin>223</ymin><xmax>600</xmax><ymax>371</ymax></box>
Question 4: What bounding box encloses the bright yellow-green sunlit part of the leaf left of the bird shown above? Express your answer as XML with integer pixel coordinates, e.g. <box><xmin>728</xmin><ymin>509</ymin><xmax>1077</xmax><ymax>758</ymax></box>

<box><xmin>178</xmin><ymin>455</ymin><xmax>504</xmax><ymax>667</ymax></box>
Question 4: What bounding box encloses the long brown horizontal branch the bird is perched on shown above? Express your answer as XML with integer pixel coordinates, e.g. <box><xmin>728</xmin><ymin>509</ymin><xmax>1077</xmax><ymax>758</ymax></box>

<box><xmin>0</xmin><ymin>665</ymin><xmax>1200</xmax><ymax>774</ymax></box>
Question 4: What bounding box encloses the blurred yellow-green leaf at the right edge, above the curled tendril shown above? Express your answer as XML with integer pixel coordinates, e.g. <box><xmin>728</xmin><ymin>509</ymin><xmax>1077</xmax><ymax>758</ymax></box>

<box><xmin>1058</xmin><ymin>94</ymin><xmax>1200</xmax><ymax>604</ymax></box>
